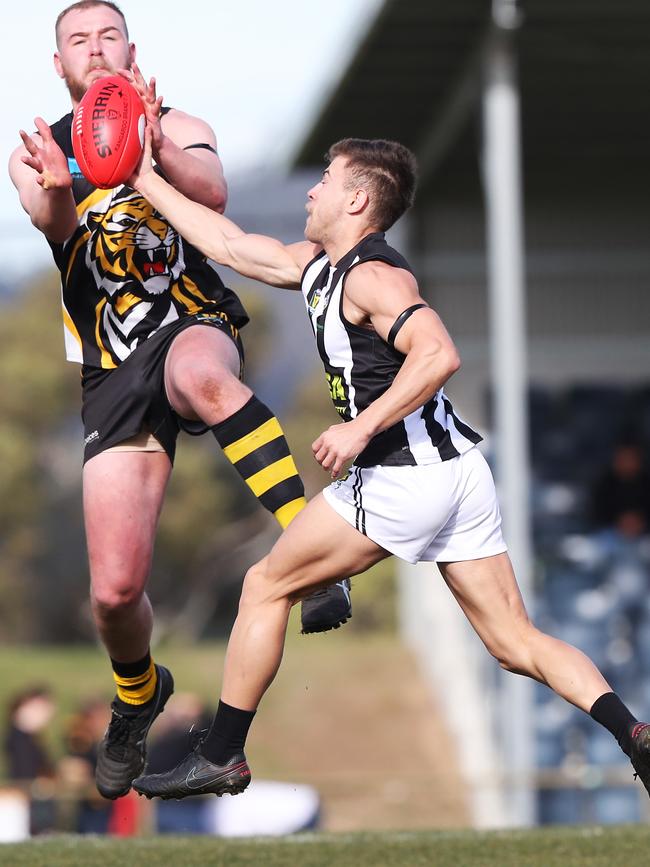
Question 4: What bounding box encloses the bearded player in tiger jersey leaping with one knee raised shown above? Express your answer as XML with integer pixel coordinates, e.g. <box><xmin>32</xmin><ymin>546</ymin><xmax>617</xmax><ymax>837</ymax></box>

<box><xmin>9</xmin><ymin>0</ymin><xmax>351</xmax><ymax>798</ymax></box>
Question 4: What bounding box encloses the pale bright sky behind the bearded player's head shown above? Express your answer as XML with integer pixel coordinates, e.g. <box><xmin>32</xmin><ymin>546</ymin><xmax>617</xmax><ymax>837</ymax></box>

<box><xmin>0</xmin><ymin>0</ymin><xmax>381</xmax><ymax>279</ymax></box>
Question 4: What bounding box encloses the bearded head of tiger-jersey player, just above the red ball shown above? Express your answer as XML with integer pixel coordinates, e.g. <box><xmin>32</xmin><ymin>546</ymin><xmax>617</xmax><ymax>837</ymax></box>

<box><xmin>54</xmin><ymin>6</ymin><xmax>135</xmax><ymax>104</ymax></box>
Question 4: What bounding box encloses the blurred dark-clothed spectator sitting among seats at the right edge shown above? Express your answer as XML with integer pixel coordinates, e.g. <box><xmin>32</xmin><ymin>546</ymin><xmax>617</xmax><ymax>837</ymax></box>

<box><xmin>591</xmin><ymin>441</ymin><xmax>650</xmax><ymax>539</ymax></box>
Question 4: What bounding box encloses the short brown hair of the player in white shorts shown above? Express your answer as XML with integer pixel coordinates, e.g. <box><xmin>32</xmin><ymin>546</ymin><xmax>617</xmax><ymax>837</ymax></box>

<box><xmin>325</xmin><ymin>138</ymin><xmax>417</xmax><ymax>231</ymax></box>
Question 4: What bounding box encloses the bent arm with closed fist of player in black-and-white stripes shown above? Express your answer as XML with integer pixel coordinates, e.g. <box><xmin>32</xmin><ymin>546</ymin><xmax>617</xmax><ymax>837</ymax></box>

<box><xmin>312</xmin><ymin>262</ymin><xmax>460</xmax><ymax>478</ymax></box>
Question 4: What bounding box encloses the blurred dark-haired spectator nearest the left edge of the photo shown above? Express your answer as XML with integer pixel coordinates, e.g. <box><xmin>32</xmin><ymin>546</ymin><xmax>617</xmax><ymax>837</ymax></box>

<box><xmin>4</xmin><ymin>686</ymin><xmax>55</xmax><ymax>782</ymax></box>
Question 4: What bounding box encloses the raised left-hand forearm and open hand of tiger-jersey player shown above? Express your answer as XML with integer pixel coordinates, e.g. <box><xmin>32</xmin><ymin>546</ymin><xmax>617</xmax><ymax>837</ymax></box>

<box><xmin>9</xmin><ymin>118</ymin><xmax>77</xmax><ymax>244</ymax></box>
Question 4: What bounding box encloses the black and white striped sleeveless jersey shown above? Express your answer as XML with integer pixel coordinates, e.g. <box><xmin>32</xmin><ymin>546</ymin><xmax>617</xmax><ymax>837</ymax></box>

<box><xmin>301</xmin><ymin>232</ymin><xmax>481</xmax><ymax>467</ymax></box>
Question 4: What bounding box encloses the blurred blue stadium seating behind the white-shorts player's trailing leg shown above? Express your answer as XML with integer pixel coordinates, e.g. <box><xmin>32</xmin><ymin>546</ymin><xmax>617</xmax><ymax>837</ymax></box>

<box><xmin>529</xmin><ymin>385</ymin><xmax>650</xmax><ymax>824</ymax></box>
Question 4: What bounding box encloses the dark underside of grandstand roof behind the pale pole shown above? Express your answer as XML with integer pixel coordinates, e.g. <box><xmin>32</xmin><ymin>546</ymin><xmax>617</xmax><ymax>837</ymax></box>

<box><xmin>294</xmin><ymin>0</ymin><xmax>650</xmax><ymax>197</ymax></box>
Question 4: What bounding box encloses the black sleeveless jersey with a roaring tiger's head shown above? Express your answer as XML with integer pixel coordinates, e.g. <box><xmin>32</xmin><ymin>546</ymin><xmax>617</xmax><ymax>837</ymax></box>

<box><xmin>50</xmin><ymin>113</ymin><xmax>248</xmax><ymax>368</ymax></box>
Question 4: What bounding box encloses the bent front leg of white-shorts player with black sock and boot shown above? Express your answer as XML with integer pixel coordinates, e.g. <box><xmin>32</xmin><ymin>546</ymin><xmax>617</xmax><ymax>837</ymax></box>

<box><xmin>133</xmin><ymin>494</ymin><xmax>388</xmax><ymax>798</ymax></box>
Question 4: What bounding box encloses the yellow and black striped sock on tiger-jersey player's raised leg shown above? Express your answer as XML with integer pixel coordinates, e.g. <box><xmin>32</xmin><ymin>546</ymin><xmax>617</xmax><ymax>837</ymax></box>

<box><xmin>212</xmin><ymin>395</ymin><xmax>307</xmax><ymax>529</ymax></box>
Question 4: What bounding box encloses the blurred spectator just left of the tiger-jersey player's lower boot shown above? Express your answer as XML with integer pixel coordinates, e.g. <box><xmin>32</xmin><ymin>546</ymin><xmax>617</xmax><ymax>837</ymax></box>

<box><xmin>58</xmin><ymin>698</ymin><xmax>113</xmax><ymax>834</ymax></box>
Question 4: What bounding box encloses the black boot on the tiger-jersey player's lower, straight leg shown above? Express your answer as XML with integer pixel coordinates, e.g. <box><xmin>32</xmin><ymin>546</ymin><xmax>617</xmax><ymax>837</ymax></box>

<box><xmin>95</xmin><ymin>665</ymin><xmax>174</xmax><ymax>800</ymax></box>
